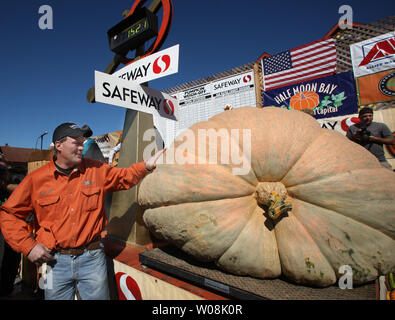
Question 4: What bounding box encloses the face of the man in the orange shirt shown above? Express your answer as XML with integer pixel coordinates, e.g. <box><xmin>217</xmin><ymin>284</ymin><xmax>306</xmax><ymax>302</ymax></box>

<box><xmin>55</xmin><ymin>137</ymin><xmax>85</xmax><ymax>167</ymax></box>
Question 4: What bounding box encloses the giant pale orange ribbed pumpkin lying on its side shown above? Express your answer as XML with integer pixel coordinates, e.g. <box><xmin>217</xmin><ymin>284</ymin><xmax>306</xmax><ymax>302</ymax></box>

<box><xmin>139</xmin><ymin>107</ymin><xmax>395</xmax><ymax>286</ymax></box>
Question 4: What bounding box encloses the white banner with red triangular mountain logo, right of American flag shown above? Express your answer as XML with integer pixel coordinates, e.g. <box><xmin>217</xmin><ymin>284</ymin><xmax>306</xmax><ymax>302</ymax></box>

<box><xmin>350</xmin><ymin>31</ymin><xmax>395</xmax><ymax>78</ymax></box>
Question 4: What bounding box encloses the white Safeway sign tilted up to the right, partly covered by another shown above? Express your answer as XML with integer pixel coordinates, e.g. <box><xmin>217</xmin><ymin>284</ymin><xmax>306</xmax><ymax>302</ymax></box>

<box><xmin>113</xmin><ymin>44</ymin><xmax>179</xmax><ymax>83</ymax></box>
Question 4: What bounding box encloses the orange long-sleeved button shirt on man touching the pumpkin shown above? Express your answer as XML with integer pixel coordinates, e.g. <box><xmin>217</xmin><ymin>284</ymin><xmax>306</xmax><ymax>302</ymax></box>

<box><xmin>0</xmin><ymin>159</ymin><xmax>148</xmax><ymax>255</ymax></box>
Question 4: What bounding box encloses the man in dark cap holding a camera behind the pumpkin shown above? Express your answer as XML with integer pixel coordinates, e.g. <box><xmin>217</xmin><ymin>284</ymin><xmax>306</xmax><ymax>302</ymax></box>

<box><xmin>346</xmin><ymin>107</ymin><xmax>395</xmax><ymax>170</ymax></box>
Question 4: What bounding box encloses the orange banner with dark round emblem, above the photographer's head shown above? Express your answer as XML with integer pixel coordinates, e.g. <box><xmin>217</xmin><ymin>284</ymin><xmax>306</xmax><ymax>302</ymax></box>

<box><xmin>356</xmin><ymin>69</ymin><xmax>395</xmax><ymax>105</ymax></box>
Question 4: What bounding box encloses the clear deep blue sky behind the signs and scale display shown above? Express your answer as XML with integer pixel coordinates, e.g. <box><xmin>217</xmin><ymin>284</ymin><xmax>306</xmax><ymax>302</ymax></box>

<box><xmin>0</xmin><ymin>0</ymin><xmax>395</xmax><ymax>148</ymax></box>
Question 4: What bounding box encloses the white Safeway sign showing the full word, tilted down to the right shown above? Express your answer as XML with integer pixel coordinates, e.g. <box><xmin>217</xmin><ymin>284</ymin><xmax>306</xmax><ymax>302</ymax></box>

<box><xmin>95</xmin><ymin>71</ymin><xmax>178</xmax><ymax>121</ymax></box>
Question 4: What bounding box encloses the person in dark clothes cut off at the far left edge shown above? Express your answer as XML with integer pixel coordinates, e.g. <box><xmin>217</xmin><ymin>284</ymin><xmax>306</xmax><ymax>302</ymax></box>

<box><xmin>0</xmin><ymin>156</ymin><xmax>21</xmax><ymax>297</ymax></box>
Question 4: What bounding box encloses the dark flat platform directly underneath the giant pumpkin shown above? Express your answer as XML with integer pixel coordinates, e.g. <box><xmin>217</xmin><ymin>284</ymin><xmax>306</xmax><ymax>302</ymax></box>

<box><xmin>139</xmin><ymin>246</ymin><xmax>376</xmax><ymax>300</ymax></box>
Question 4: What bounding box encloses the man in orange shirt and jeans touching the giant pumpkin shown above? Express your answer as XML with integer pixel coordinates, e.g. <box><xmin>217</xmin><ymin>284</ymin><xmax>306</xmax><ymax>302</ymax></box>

<box><xmin>0</xmin><ymin>123</ymin><xmax>164</xmax><ymax>300</ymax></box>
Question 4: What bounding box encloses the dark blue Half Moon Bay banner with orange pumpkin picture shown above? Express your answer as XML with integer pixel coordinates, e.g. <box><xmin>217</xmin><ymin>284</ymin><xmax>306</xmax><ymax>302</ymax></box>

<box><xmin>262</xmin><ymin>71</ymin><xmax>358</xmax><ymax>119</ymax></box>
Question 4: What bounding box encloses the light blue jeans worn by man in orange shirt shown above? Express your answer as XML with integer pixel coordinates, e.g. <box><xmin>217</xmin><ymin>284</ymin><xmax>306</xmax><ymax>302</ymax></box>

<box><xmin>44</xmin><ymin>248</ymin><xmax>110</xmax><ymax>300</ymax></box>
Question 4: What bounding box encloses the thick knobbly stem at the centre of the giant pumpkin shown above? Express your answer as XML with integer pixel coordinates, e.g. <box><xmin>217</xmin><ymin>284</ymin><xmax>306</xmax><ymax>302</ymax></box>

<box><xmin>255</xmin><ymin>182</ymin><xmax>292</xmax><ymax>220</ymax></box>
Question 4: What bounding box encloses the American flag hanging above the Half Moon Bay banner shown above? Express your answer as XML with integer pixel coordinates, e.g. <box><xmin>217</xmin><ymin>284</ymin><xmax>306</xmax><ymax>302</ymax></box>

<box><xmin>262</xmin><ymin>39</ymin><xmax>336</xmax><ymax>91</ymax></box>
